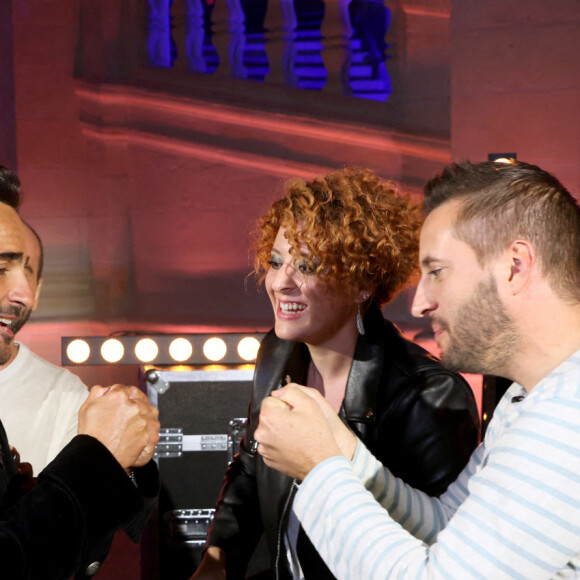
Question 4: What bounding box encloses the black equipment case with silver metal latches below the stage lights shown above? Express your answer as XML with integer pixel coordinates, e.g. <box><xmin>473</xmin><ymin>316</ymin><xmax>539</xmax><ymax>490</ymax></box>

<box><xmin>142</xmin><ymin>366</ymin><xmax>266</xmax><ymax>580</ymax></box>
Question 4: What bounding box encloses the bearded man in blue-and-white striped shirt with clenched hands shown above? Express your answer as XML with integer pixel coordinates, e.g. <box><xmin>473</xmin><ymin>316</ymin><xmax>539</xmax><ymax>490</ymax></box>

<box><xmin>256</xmin><ymin>162</ymin><xmax>580</xmax><ymax>580</ymax></box>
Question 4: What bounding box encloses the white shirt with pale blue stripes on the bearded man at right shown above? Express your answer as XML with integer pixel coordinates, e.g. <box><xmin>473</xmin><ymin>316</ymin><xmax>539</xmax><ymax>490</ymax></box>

<box><xmin>294</xmin><ymin>351</ymin><xmax>580</xmax><ymax>580</ymax></box>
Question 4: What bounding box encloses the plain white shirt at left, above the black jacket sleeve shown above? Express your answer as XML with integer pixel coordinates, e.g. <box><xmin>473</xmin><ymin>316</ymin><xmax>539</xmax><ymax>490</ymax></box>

<box><xmin>0</xmin><ymin>344</ymin><xmax>89</xmax><ymax>476</ymax></box>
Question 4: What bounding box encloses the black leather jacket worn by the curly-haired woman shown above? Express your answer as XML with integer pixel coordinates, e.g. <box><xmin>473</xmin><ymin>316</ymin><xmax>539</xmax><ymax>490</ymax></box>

<box><xmin>206</xmin><ymin>309</ymin><xmax>479</xmax><ymax>580</ymax></box>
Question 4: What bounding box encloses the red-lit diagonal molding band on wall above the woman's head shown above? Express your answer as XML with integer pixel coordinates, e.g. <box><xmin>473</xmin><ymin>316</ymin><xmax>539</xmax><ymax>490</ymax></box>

<box><xmin>76</xmin><ymin>81</ymin><xmax>450</xmax><ymax>193</ymax></box>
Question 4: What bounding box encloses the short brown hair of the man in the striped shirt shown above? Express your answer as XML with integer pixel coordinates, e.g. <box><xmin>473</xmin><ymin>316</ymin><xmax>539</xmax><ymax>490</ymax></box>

<box><xmin>423</xmin><ymin>161</ymin><xmax>580</xmax><ymax>303</ymax></box>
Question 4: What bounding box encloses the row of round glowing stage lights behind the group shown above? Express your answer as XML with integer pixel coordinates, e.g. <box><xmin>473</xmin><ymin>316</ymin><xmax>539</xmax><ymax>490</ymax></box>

<box><xmin>61</xmin><ymin>333</ymin><xmax>264</xmax><ymax>366</ymax></box>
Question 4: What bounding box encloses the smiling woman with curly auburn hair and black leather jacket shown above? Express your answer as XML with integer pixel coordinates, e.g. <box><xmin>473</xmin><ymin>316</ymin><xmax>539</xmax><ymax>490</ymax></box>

<box><xmin>194</xmin><ymin>168</ymin><xmax>479</xmax><ymax>580</ymax></box>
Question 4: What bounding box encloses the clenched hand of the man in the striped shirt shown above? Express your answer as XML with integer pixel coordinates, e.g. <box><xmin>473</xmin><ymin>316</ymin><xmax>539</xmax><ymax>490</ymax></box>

<box><xmin>254</xmin><ymin>383</ymin><xmax>357</xmax><ymax>481</ymax></box>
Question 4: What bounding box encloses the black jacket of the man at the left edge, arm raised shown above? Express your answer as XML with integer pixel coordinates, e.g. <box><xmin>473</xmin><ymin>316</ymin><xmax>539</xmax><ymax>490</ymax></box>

<box><xmin>0</xmin><ymin>423</ymin><xmax>159</xmax><ymax>580</ymax></box>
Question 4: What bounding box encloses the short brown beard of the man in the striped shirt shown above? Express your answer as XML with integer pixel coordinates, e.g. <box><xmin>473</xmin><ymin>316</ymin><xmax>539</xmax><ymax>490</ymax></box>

<box><xmin>441</xmin><ymin>276</ymin><xmax>519</xmax><ymax>376</ymax></box>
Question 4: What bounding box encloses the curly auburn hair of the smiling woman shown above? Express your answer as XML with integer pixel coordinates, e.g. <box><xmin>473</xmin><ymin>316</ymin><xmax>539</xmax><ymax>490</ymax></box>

<box><xmin>253</xmin><ymin>167</ymin><xmax>422</xmax><ymax>306</ymax></box>
